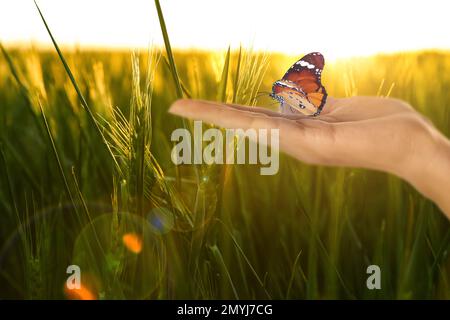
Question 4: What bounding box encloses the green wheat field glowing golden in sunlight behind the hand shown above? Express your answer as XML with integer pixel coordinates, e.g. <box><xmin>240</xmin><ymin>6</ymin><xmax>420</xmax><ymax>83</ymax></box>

<box><xmin>0</xmin><ymin>1</ymin><xmax>450</xmax><ymax>299</ymax></box>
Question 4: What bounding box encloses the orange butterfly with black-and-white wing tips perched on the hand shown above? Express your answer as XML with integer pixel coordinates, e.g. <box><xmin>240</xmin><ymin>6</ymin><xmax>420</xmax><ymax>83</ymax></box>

<box><xmin>270</xmin><ymin>52</ymin><xmax>327</xmax><ymax>116</ymax></box>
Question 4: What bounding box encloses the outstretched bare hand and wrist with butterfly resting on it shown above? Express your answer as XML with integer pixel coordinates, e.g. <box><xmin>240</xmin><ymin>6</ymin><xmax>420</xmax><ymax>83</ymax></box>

<box><xmin>170</xmin><ymin>97</ymin><xmax>450</xmax><ymax>219</ymax></box>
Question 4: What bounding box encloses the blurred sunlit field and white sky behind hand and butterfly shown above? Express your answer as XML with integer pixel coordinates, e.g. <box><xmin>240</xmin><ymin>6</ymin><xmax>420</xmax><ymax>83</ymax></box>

<box><xmin>0</xmin><ymin>0</ymin><xmax>450</xmax><ymax>299</ymax></box>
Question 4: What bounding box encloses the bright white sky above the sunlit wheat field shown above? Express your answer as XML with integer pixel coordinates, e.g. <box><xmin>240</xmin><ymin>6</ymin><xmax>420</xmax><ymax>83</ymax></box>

<box><xmin>0</xmin><ymin>0</ymin><xmax>450</xmax><ymax>57</ymax></box>
